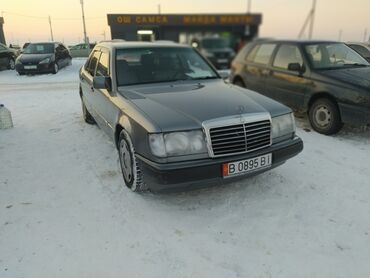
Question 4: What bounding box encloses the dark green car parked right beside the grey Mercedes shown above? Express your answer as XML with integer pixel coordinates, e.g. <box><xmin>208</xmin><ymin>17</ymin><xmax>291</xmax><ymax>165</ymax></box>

<box><xmin>230</xmin><ymin>40</ymin><xmax>370</xmax><ymax>134</ymax></box>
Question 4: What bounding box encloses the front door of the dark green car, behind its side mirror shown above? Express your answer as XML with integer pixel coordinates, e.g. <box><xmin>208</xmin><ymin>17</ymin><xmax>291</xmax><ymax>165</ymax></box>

<box><xmin>266</xmin><ymin>43</ymin><xmax>309</xmax><ymax>108</ymax></box>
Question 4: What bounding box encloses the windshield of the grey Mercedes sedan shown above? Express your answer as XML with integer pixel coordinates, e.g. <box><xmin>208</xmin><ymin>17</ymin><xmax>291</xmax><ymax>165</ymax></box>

<box><xmin>116</xmin><ymin>47</ymin><xmax>218</xmax><ymax>86</ymax></box>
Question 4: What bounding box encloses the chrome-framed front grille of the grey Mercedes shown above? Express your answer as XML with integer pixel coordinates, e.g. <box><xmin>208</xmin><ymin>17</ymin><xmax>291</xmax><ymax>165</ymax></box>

<box><xmin>209</xmin><ymin>120</ymin><xmax>271</xmax><ymax>156</ymax></box>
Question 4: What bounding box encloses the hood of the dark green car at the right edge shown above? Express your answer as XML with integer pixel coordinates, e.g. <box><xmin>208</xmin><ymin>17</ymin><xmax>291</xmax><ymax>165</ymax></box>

<box><xmin>322</xmin><ymin>67</ymin><xmax>370</xmax><ymax>91</ymax></box>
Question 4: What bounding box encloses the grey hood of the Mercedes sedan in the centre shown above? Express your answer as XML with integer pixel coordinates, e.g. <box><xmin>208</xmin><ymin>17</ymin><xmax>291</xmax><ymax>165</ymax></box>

<box><xmin>120</xmin><ymin>80</ymin><xmax>290</xmax><ymax>132</ymax></box>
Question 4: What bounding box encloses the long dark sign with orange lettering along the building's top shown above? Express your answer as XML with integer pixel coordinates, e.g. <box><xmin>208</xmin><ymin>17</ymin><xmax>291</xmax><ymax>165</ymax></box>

<box><xmin>108</xmin><ymin>14</ymin><xmax>261</xmax><ymax>25</ymax></box>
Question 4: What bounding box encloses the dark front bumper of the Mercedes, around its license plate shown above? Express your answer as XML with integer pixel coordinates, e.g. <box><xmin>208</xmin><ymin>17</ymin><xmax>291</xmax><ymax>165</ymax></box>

<box><xmin>136</xmin><ymin>137</ymin><xmax>303</xmax><ymax>191</ymax></box>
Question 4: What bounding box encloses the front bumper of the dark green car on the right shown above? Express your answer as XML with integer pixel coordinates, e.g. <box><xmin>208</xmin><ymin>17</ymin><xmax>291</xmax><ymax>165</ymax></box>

<box><xmin>339</xmin><ymin>103</ymin><xmax>370</xmax><ymax>125</ymax></box>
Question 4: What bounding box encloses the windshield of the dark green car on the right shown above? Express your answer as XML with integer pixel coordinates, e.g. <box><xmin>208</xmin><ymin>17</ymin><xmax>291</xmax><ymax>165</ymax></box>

<box><xmin>305</xmin><ymin>43</ymin><xmax>369</xmax><ymax>69</ymax></box>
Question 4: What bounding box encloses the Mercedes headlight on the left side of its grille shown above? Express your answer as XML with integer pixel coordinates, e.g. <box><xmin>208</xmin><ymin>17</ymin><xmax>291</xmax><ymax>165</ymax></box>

<box><xmin>149</xmin><ymin>130</ymin><xmax>207</xmax><ymax>157</ymax></box>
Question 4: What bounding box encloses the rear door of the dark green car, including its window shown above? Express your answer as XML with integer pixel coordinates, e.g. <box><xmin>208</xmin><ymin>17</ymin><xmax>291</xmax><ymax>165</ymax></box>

<box><xmin>242</xmin><ymin>43</ymin><xmax>276</xmax><ymax>95</ymax></box>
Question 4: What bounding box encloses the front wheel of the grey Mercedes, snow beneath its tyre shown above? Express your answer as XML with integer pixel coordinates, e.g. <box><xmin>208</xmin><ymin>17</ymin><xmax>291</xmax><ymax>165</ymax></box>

<box><xmin>118</xmin><ymin>130</ymin><xmax>145</xmax><ymax>192</ymax></box>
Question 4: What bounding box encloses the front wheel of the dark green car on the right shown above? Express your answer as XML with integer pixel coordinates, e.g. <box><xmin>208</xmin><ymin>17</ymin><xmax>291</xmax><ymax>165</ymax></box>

<box><xmin>308</xmin><ymin>98</ymin><xmax>343</xmax><ymax>135</ymax></box>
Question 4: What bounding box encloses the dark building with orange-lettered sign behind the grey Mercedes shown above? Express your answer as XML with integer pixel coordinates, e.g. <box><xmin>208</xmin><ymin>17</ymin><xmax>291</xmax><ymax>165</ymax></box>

<box><xmin>107</xmin><ymin>14</ymin><xmax>262</xmax><ymax>43</ymax></box>
